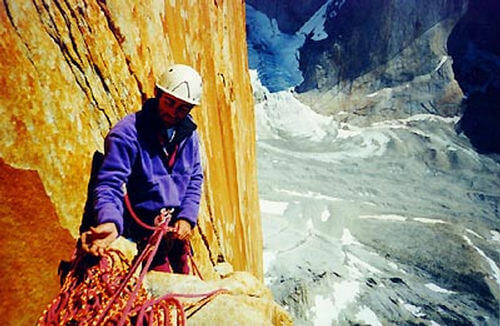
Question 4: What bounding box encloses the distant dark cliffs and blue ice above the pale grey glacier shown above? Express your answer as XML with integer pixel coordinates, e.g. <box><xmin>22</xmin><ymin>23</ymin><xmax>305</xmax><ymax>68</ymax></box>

<box><xmin>247</xmin><ymin>0</ymin><xmax>500</xmax><ymax>153</ymax></box>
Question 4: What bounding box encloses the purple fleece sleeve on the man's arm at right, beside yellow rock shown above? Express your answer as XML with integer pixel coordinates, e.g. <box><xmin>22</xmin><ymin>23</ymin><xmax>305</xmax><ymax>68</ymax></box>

<box><xmin>177</xmin><ymin>132</ymin><xmax>203</xmax><ymax>227</ymax></box>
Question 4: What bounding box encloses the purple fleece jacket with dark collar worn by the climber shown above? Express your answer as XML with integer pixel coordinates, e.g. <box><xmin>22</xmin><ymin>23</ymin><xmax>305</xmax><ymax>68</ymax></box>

<box><xmin>94</xmin><ymin>99</ymin><xmax>203</xmax><ymax>239</ymax></box>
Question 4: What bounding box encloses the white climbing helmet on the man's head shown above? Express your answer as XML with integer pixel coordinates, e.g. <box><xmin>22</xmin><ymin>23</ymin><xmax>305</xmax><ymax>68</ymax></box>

<box><xmin>156</xmin><ymin>64</ymin><xmax>202</xmax><ymax>105</ymax></box>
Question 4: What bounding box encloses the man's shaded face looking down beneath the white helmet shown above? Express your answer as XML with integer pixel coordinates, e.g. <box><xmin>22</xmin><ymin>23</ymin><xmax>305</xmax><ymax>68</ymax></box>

<box><xmin>156</xmin><ymin>91</ymin><xmax>193</xmax><ymax>128</ymax></box>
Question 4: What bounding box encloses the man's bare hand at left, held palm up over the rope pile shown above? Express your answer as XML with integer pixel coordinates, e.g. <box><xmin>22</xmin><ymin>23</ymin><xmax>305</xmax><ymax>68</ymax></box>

<box><xmin>81</xmin><ymin>222</ymin><xmax>118</xmax><ymax>256</ymax></box>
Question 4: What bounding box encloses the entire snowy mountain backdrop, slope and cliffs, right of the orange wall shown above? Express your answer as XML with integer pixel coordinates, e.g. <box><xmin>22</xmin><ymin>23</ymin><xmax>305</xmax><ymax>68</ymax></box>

<box><xmin>247</xmin><ymin>0</ymin><xmax>500</xmax><ymax>326</ymax></box>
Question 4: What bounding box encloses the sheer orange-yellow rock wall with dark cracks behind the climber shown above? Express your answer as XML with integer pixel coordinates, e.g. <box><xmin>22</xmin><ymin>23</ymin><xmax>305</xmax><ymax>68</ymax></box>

<box><xmin>0</xmin><ymin>0</ymin><xmax>282</xmax><ymax>325</ymax></box>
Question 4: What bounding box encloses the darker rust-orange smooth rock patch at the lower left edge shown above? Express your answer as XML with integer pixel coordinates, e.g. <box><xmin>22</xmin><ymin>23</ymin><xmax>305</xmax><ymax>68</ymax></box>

<box><xmin>0</xmin><ymin>159</ymin><xmax>74</xmax><ymax>325</ymax></box>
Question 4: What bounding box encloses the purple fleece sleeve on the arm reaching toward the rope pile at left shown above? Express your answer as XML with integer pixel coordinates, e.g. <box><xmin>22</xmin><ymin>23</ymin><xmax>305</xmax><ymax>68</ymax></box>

<box><xmin>94</xmin><ymin>130</ymin><xmax>137</xmax><ymax>234</ymax></box>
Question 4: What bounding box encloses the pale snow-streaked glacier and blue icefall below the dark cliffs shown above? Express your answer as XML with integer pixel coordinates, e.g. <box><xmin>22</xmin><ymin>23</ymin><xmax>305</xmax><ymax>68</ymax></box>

<box><xmin>247</xmin><ymin>1</ymin><xmax>500</xmax><ymax>325</ymax></box>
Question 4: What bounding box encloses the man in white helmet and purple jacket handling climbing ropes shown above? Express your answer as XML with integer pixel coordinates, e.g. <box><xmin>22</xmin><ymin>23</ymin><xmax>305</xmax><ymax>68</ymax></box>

<box><xmin>81</xmin><ymin>64</ymin><xmax>203</xmax><ymax>273</ymax></box>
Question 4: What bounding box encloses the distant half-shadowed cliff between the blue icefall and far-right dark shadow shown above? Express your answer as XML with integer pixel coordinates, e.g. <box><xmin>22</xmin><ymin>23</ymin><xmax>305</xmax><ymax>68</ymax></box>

<box><xmin>296</xmin><ymin>0</ymin><xmax>467</xmax><ymax>120</ymax></box>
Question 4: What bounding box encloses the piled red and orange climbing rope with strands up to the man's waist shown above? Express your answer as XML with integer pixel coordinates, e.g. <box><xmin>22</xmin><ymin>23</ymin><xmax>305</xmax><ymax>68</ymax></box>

<box><xmin>38</xmin><ymin>195</ymin><xmax>228</xmax><ymax>326</ymax></box>
